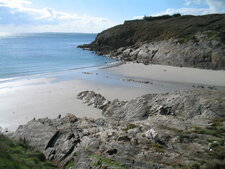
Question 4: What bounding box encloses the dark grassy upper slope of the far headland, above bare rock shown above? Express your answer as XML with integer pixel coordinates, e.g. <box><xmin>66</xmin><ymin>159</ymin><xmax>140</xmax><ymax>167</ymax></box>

<box><xmin>93</xmin><ymin>14</ymin><xmax>225</xmax><ymax>52</ymax></box>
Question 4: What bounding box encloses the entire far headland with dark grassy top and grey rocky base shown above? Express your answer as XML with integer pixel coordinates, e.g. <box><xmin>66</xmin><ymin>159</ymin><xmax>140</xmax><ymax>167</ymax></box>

<box><xmin>79</xmin><ymin>14</ymin><xmax>225</xmax><ymax>69</ymax></box>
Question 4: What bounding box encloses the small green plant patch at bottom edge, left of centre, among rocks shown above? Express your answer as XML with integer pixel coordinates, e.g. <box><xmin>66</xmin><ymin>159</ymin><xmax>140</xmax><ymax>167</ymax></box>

<box><xmin>91</xmin><ymin>155</ymin><xmax>128</xmax><ymax>169</ymax></box>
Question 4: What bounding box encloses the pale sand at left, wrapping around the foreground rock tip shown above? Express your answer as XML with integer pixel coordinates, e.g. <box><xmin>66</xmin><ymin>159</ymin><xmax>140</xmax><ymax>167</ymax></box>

<box><xmin>0</xmin><ymin>68</ymin><xmax>153</xmax><ymax>130</ymax></box>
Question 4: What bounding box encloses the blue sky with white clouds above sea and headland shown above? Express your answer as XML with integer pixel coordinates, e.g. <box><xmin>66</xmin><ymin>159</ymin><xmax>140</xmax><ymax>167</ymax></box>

<box><xmin>0</xmin><ymin>0</ymin><xmax>225</xmax><ymax>35</ymax></box>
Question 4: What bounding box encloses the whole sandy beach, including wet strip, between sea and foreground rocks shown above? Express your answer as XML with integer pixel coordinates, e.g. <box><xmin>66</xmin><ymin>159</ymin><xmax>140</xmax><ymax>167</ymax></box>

<box><xmin>0</xmin><ymin>63</ymin><xmax>225</xmax><ymax>130</ymax></box>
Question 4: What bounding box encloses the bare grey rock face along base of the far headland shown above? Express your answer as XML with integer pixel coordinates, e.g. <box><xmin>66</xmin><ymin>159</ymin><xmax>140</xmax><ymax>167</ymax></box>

<box><xmin>110</xmin><ymin>34</ymin><xmax>225</xmax><ymax>69</ymax></box>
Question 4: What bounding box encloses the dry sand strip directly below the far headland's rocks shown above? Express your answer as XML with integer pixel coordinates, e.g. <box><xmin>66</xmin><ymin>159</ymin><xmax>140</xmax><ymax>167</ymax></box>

<box><xmin>105</xmin><ymin>62</ymin><xmax>225</xmax><ymax>87</ymax></box>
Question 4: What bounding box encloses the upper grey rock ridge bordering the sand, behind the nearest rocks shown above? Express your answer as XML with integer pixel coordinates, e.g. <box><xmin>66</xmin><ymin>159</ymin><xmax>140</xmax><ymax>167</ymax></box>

<box><xmin>78</xmin><ymin>89</ymin><xmax>225</xmax><ymax>122</ymax></box>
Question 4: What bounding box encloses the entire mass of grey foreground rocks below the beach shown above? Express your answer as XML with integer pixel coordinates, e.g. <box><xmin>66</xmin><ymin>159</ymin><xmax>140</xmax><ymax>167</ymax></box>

<box><xmin>12</xmin><ymin>89</ymin><xmax>225</xmax><ymax>169</ymax></box>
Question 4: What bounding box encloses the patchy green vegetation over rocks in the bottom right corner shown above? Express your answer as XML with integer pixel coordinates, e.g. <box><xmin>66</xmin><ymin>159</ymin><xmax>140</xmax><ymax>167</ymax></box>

<box><xmin>160</xmin><ymin>121</ymin><xmax>225</xmax><ymax>169</ymax></box>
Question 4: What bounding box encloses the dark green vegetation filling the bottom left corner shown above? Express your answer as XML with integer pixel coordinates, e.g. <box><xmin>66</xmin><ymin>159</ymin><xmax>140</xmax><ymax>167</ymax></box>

<box><xmin>0</xmin><ymin>134</ymin><xmax>57</xmax><ymax>169</ymax></box>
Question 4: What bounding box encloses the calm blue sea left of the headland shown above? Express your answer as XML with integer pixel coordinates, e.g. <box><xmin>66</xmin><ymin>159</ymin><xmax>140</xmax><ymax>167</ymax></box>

<box><xmin>0</xmin><ymin>33</ymin><xmax>114</xmax><ymax>80</ymax></box>
